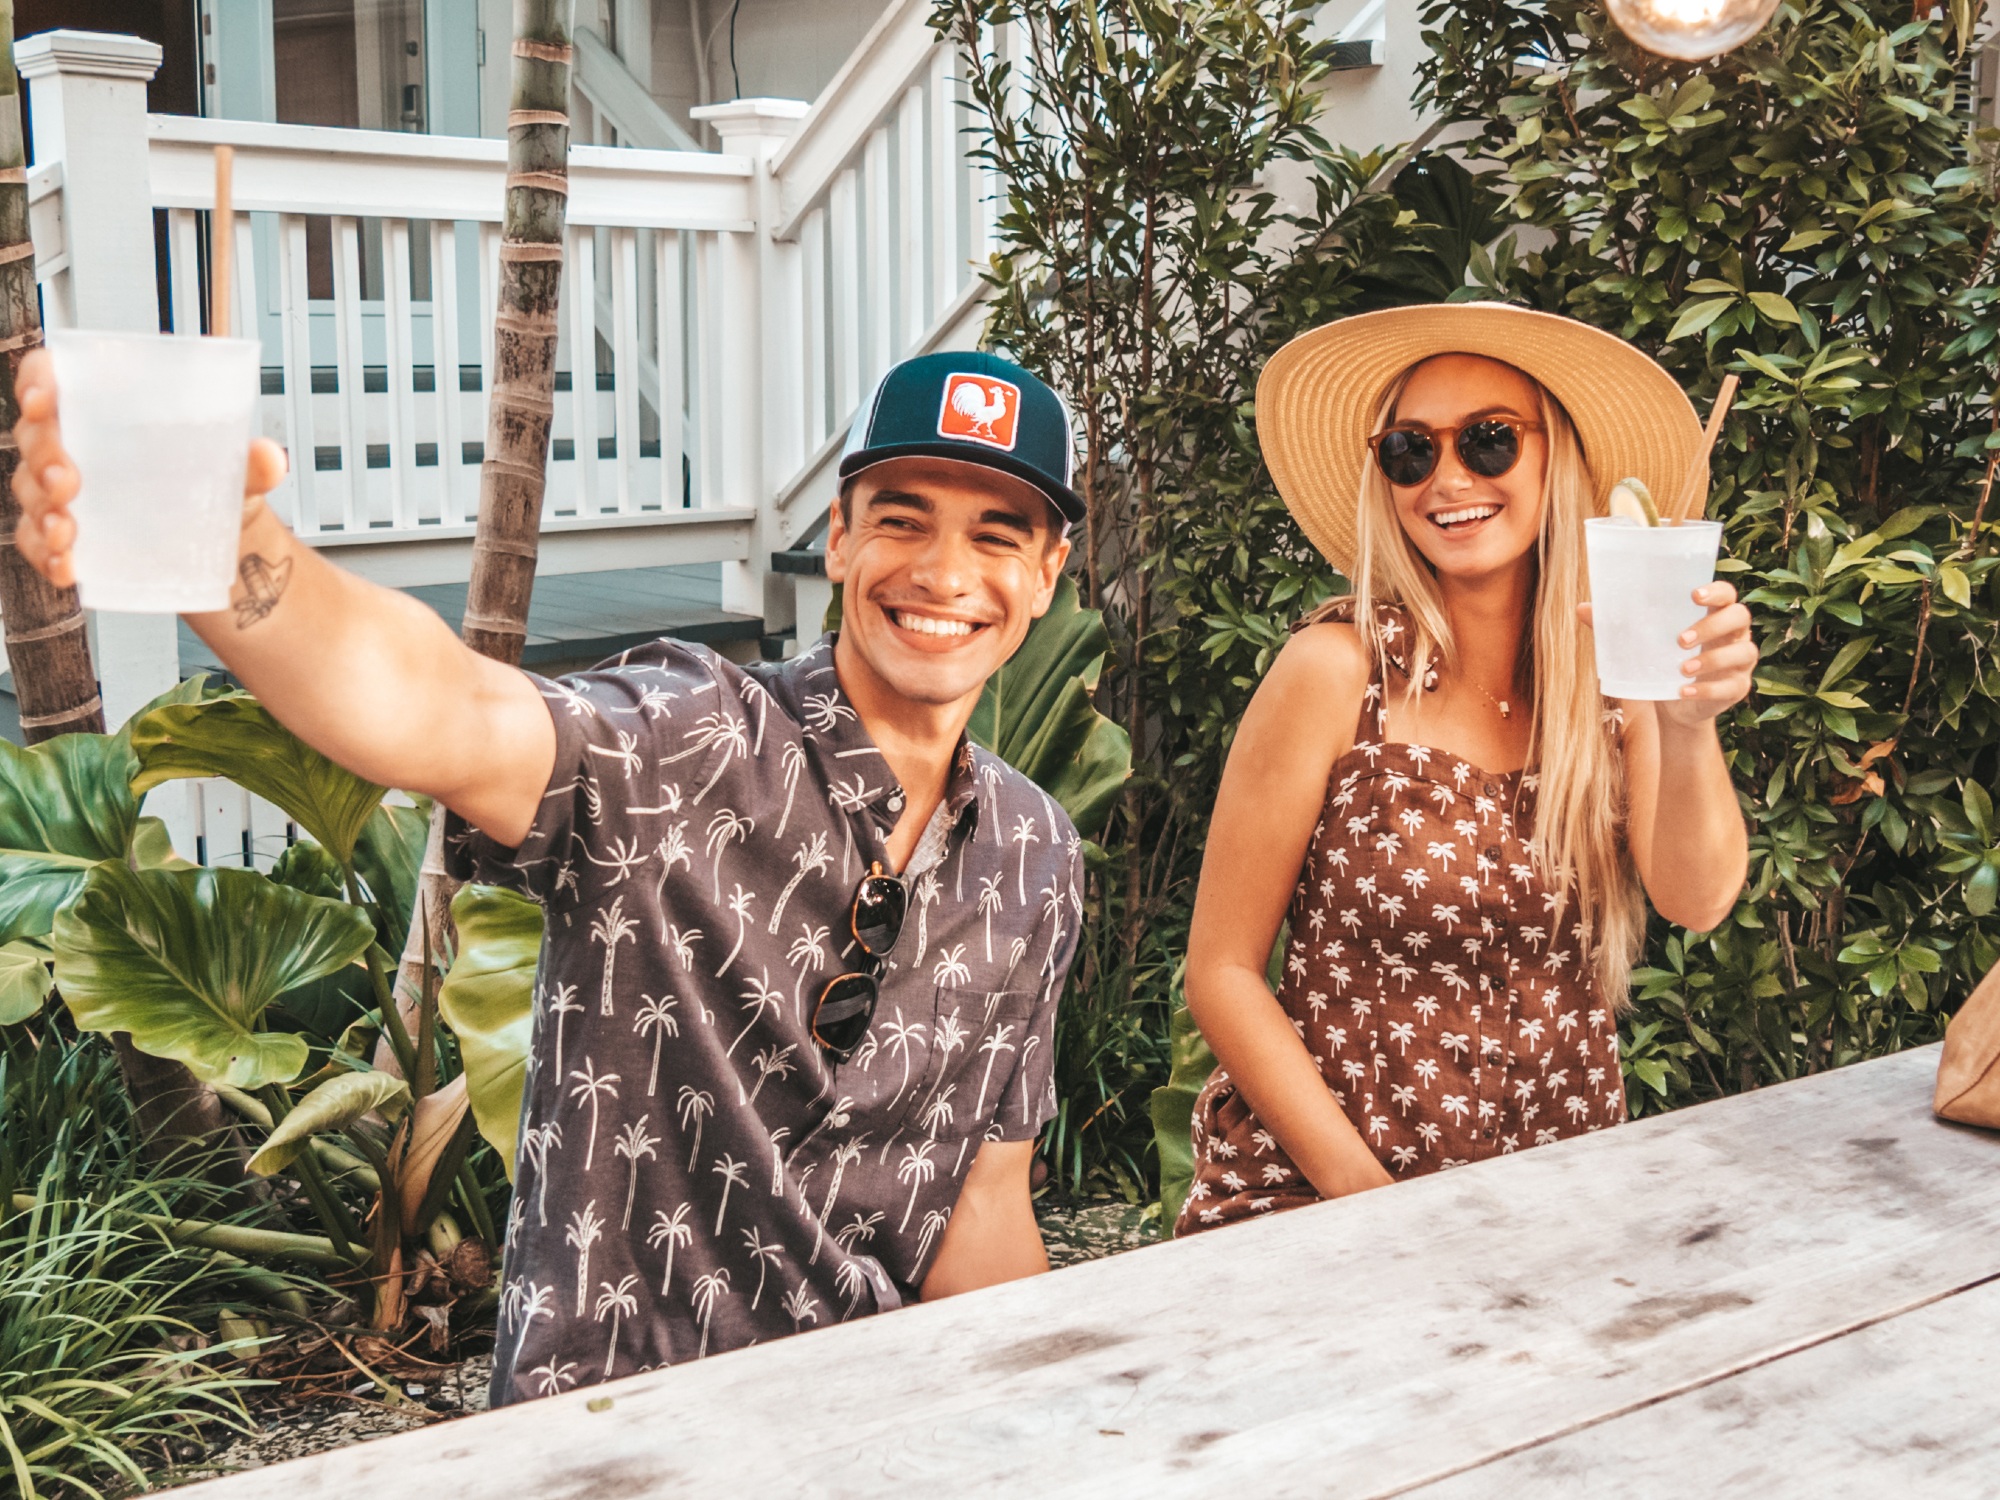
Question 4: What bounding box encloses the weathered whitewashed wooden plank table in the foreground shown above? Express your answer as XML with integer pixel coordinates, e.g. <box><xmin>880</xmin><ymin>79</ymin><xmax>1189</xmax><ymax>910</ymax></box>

<box><xmin>190</xmin><ymin>1048</ymin><xmax>2000</xmax><ymax>1500</ymax></box>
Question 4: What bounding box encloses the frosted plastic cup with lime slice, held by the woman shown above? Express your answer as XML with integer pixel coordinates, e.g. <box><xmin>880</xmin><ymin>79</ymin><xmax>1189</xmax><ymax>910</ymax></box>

<box><xmin>1584</xmin><ymin>516</ymin><xmax>1722</xmax><ymax>702</ymax></box>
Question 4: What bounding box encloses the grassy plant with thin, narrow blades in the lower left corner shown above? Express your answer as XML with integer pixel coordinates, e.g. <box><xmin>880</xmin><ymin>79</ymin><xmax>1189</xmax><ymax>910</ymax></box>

<box><xmin>0</xmin><ymin>1026</ymin><xmax>308</xmax><ymax>1498</ymax></box>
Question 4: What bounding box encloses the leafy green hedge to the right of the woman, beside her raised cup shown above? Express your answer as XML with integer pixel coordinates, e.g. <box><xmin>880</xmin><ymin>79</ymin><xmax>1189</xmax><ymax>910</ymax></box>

<box><xmin>1422</xmin><ymin>0</ymin><xmax>2000</xmax><ymax>1108</ymax></box>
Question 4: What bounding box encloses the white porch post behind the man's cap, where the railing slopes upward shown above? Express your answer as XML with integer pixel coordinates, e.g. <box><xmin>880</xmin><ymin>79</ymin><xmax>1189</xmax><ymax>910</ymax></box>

<box><xmin>688</xmin><ymin>98</ymin><xmax>810</xmax><ymax>630</ymax></box>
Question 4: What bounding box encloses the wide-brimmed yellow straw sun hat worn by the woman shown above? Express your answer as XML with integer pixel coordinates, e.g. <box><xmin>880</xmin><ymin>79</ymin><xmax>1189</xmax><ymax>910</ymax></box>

<box><xmin>1256</xmin><ymin>302</ymin><xmax>1702</xmax><ymax>574</ymax></box>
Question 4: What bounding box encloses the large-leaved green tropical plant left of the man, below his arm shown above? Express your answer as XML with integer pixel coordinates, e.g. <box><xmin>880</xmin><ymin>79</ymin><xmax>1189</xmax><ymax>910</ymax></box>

<box><xmin>0</xmin><ymin>680</ymin><xmax>494</xmax><ymax>1328</ymax></box>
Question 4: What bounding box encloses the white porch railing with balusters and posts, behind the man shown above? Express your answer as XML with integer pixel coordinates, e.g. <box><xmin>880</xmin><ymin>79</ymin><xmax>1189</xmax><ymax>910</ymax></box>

<box><xmin>20</xmin><ymin>17</ymin><xmax>1006</xmax><ymax>732</ymax></box>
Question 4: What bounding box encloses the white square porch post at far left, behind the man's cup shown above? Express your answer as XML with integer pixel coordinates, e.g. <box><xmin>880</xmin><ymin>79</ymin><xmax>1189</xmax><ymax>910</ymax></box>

<box><xmin>14</xmin><ymin>32</ymin><xmax>180</xmax><ymax>728</ymax></box>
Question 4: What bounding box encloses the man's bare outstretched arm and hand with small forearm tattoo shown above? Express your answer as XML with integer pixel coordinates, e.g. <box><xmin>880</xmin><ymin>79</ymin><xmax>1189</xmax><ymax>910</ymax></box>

<box><xmin>14</xmin><ymin>350</ymin><xmax>556</xmax><ymax>846</ymax></box>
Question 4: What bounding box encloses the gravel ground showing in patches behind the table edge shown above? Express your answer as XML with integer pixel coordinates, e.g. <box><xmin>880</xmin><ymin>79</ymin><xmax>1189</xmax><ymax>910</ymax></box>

<box><xmin>174</xmin><ymin>1202</ymin><xmax>1160</xmax><ymax>1482</ymax></box>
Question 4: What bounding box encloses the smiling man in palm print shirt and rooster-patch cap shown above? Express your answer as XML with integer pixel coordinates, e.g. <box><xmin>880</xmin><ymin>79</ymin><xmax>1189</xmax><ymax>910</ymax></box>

<box><xmin>16</xmin><ymin>354</ymin><xmax>1082</xmax><ymax>1402</ymax></box>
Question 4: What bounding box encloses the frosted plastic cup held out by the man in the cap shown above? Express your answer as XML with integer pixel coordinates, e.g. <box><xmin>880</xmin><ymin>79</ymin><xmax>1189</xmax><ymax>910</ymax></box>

<box><xmin>48</xmin><ymin>332</ymin><xmax>262</xmax><ymax>614</ymax></box>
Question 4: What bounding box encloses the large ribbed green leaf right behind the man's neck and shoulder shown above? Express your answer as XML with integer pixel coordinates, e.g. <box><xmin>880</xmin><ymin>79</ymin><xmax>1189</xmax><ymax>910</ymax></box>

<box><xmin>966</xmin><ymin>576</ymin><xmax>1132</xmax><ymax>838</ymax></box>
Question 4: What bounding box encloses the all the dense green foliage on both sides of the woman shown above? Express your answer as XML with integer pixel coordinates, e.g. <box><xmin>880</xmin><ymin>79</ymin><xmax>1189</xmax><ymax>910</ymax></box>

<box><xmin>936</xmin><ymin>0</ymin><xmax>2000</xmax><ymax>1198</ymax></box>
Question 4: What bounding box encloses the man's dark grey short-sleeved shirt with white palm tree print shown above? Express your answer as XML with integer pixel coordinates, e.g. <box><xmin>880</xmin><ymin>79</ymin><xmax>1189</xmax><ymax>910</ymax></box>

<box><xmin>450</xmin><ymin>636</ymin><xmax>1082</xmax><ymax>1404</ymax></box>
